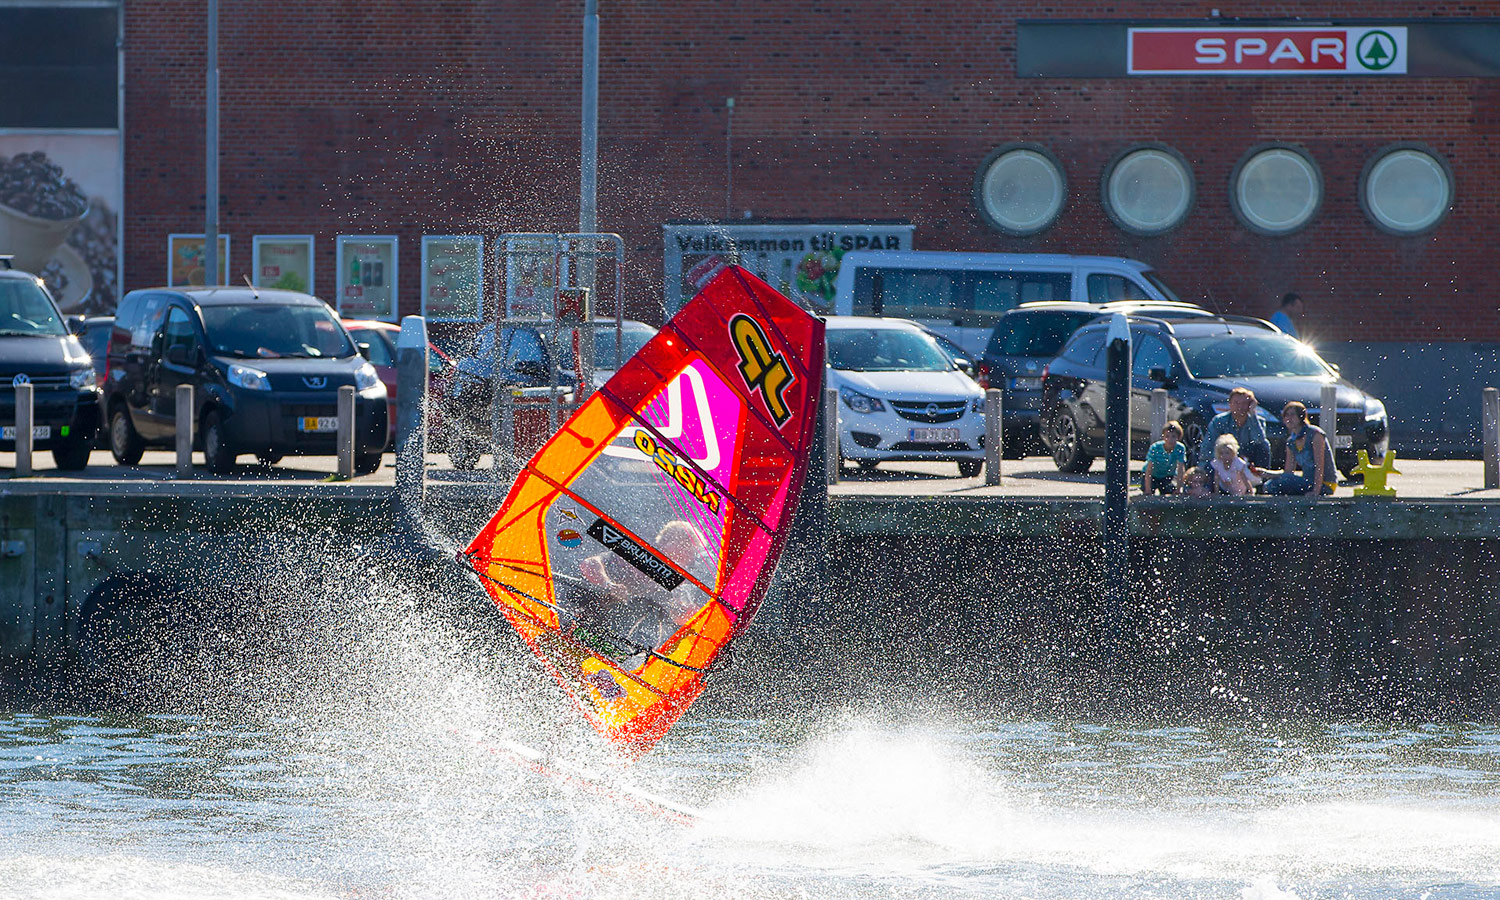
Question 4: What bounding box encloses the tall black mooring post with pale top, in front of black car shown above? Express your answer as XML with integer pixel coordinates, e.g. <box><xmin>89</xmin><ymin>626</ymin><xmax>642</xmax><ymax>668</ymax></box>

<box><xmin>1104</xmin><ymin>314</ymin><xmax>1130</xmax><ymax>617</ymax></box>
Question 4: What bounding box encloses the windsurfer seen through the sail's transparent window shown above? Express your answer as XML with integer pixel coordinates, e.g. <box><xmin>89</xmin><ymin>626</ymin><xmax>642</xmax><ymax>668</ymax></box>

<box><xmin>579</xmin><ymin>519</ymin><xmax>711</xmax><ymax>648</ymax></box>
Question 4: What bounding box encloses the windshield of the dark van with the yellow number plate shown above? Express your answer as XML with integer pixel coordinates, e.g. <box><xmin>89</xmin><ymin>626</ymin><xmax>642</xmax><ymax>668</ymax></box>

<box><xmin>203</xmin><ymin>303</ymin><xmax>356</xmax><ymax>360</ymax></box>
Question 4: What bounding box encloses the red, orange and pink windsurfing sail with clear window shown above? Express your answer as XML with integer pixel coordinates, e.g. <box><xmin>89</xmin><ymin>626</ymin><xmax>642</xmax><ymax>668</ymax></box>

<box><xmin>465</xmin><ymin>266</ymin><xmax>824</xmax><ymax>755</ymax></box>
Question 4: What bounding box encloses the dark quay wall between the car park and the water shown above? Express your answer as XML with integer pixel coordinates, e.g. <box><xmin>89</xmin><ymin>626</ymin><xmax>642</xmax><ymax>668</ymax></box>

<box><xmin>0</xmin><ymin>483</ymin><xmax>1500</xmax><ymax>716</ymax></box>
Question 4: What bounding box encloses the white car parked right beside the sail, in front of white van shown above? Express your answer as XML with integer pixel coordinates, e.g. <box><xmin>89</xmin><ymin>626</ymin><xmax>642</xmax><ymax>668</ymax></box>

<box><xmin>827</xmin><ymin>315</ymin><xmax>984</xmax><ymax>479</ymax></box>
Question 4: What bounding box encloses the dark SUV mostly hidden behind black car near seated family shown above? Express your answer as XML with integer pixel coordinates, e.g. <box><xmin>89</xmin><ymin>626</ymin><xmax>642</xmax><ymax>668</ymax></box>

<box><xmin>978</xmin><ymin>300</ymin><xmax>1214</xmax><ymax>459</ymax></box>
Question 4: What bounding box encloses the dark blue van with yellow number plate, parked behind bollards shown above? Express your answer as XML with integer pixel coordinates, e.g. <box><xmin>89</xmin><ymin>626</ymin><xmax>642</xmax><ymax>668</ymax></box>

<box><xmin>104</xmin><ymin>287</ymin><xmax>387</xmax><ymax>474</ymax></box>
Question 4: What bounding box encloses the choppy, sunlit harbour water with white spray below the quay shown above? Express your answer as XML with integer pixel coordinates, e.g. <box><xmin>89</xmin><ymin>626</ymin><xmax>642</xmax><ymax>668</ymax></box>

<box><xmin>0</xmin><ymin>702</ymin><xmax>1500</xmax><ymax>900</ymax></box>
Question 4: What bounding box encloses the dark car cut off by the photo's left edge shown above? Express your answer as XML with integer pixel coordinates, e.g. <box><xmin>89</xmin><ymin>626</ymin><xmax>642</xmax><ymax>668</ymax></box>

<box><xmin>0</xmin><ymin>257</ymin><xmax>99</xmax><ymax>471</ymax></box>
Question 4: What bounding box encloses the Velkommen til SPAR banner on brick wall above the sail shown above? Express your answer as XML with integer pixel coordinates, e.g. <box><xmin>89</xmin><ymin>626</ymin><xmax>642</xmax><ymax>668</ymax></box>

<box><xmin>663</xmin><ymin>222</ymin><xmax>914</xmax><ymax>315</ymax></box>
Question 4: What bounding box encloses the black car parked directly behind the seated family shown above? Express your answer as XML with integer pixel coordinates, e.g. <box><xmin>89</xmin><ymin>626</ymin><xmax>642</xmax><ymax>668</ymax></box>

<box><xmin>1041</xmin><ymin>317</ymin><xmax>1391</xmax><ymax>476</ymax></box>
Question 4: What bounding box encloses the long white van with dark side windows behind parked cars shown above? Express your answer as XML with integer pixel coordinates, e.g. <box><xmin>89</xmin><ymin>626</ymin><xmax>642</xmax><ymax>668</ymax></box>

<box><xmin>834</xmin><ymin>251</ymin><xmax>1179</xmax><ymax>359</ymax></box>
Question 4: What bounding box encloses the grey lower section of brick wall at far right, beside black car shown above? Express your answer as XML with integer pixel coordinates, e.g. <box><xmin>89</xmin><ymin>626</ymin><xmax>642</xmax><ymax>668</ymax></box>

<box><xmin>1319</xmin><ymin>341</ymin><xmax>1500</xmax><ymax>459</ymax></box>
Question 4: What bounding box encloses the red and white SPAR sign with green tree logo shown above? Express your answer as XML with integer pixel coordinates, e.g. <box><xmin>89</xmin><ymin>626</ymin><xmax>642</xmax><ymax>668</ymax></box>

<box><xmin>1127</xmin><ymin>26</ymin><xmax>1407</xmax><ymax>75</ymax></box>
